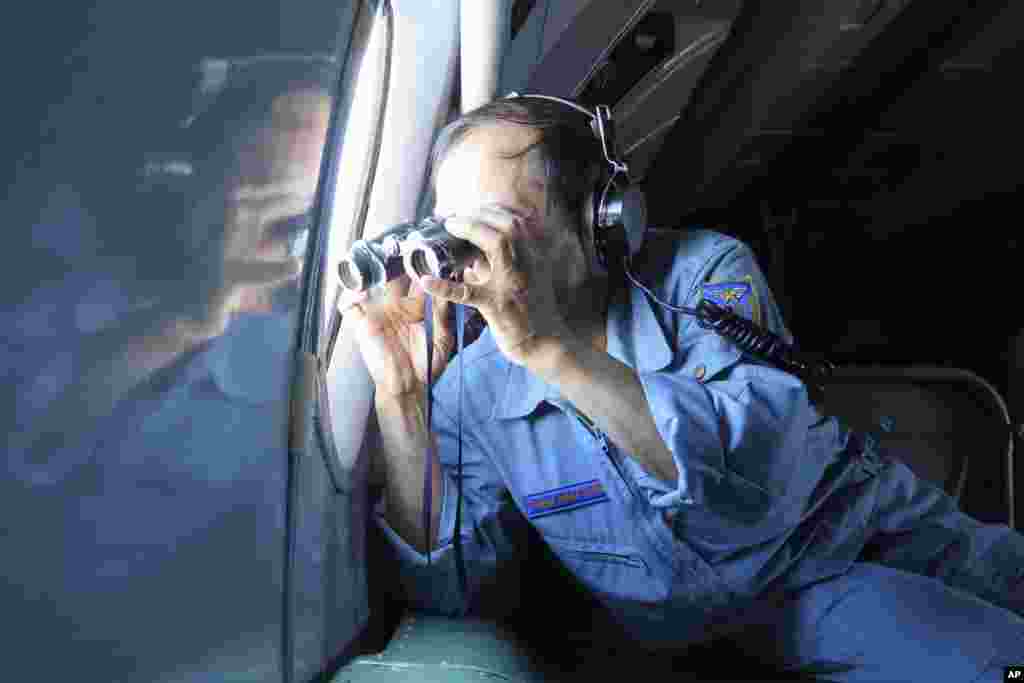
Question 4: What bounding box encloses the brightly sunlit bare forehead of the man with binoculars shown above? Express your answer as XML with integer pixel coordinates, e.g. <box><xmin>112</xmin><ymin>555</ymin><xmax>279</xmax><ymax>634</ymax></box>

<box><xmin>434</xmin><ymin>123</ymin><xmax>543</xmax><ymax>215</ymax></box>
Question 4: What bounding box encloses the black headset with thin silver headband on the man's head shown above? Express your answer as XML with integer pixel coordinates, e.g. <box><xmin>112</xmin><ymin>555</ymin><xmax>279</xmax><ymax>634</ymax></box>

<box><xmin>505</xmin><ymin>92</ymin><xmax>647</xmax><ymax>269</ymax></box>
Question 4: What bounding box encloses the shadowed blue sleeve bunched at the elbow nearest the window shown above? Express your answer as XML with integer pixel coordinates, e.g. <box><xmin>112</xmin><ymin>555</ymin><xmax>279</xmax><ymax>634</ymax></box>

<box><xmin>374</xmin><ymin>399</ymin><xmax>519</xmax><ymax>616</ymax></box>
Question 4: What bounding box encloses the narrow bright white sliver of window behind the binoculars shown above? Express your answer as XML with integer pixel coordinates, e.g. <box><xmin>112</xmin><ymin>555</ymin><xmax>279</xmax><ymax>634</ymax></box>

<box><xmin>321</xmin><ymin>9</ymin><xmax>390</xmax><ymax>352</ymax></box>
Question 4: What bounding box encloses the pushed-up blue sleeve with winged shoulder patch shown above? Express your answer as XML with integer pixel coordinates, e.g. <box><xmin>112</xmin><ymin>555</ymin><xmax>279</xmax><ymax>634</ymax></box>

<box><xmin>640</xmin><ymin>235</ymin><xmax>814</xmax><ymax>523</ymax></box>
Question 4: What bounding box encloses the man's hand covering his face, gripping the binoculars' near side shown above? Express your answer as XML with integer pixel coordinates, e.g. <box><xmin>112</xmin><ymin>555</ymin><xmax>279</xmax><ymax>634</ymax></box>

<box><xmin>406</xmin><ymin>206</ymin><xmax>571</xmax><ymax>367</ymax></box>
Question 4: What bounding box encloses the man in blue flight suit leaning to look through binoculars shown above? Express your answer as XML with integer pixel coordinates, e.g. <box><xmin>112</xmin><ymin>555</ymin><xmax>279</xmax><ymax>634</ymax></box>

<box><xmin>343</xmin><ymin>98</ymin><xmax>1024</xmax><ymax>683</ymax></box>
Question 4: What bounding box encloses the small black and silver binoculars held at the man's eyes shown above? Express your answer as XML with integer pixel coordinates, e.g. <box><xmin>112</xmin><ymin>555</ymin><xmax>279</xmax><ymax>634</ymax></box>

<box><xmin>338</xmin><ymin>218</ymin><xmax>481</xmax><ymax>292</ymax></box>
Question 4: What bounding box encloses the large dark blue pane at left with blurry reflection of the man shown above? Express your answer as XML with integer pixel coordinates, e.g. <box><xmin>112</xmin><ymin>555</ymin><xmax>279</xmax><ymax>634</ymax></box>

<box><xmin>0</xmin><ymin>0</ymin><xmax>360</xmax><ymax>682</ymax></box>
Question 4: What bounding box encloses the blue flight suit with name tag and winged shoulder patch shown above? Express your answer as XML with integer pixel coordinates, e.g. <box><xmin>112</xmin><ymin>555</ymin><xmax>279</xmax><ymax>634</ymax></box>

<box><xmin>376</xmin><ymin>230</ymin><xmax>1024</xmax><ymax>682</ymax></box>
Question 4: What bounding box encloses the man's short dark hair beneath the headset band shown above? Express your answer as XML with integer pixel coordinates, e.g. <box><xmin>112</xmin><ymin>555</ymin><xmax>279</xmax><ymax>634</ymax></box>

<box><xmin>430</xmin><ymin>97</ymin><xmax>606</xmax><ymax>235</ymax></box>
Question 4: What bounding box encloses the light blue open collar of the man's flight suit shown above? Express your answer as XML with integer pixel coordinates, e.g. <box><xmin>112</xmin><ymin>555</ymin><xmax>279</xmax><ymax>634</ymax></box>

<box><xmin>486</xmin><ymin>278</ymin><xmax>673</xmax><ymax>420</ymax></box>
